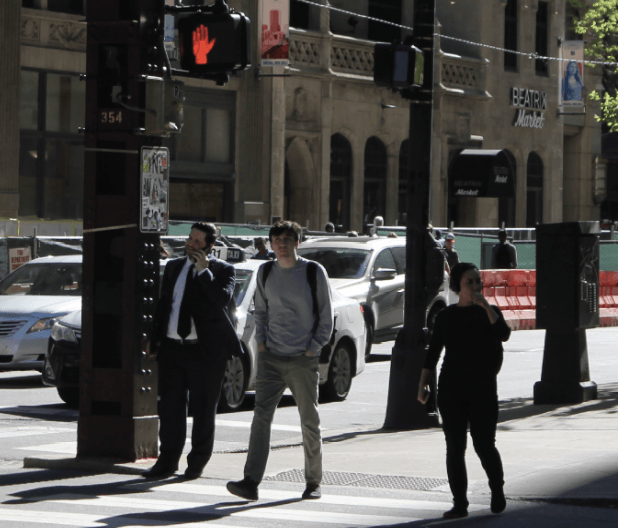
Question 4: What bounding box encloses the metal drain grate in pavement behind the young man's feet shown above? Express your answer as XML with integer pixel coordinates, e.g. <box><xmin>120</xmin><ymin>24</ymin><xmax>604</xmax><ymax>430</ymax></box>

<box><xmin>264</xmin><ymin>469</ymin><xmax>448</xmax><ymax>491</ymax></box>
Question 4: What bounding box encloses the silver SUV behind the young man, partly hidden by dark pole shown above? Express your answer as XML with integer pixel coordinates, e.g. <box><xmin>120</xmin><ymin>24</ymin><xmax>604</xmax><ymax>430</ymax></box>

<box><xmin>298</xmin><ymin>236</ymin><xmax>452</xmax><ymax>356</ymax></box>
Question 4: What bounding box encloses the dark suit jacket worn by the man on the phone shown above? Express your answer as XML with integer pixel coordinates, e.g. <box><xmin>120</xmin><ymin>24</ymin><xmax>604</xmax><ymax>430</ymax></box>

<box><xmin>150</xmin><ymin>257</ymin><xmax>243</xmax><ymax>357</ymax></box>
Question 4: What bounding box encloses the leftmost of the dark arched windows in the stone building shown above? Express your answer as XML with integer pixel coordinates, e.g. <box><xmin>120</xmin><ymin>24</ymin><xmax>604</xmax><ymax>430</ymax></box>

<box><xmin>328</xmin><ymin>134</ymin><xmax>352</xmax><ymax>231</ymax></box>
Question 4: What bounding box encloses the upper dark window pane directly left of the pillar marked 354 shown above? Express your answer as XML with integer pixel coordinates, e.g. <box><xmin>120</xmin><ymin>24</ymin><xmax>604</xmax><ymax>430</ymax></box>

<box><xmin>45</xmin><ymin>73</ymin><xmax>86</xmax><ymax>133</ymax></box>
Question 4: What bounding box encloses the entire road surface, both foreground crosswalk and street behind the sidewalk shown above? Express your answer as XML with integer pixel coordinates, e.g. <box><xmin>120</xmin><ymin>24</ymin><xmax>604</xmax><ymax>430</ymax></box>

<box><xmin>0</xmin><ymin>328</ymin><xmax>618</xmax><ymax>528</ymax></box>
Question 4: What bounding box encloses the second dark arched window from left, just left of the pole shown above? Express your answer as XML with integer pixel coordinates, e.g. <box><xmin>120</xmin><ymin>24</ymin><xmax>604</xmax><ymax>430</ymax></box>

<box><xmin>363</xmin><ymin>136</ymin><xmax>387</xmax><ymax>225</ymax></box>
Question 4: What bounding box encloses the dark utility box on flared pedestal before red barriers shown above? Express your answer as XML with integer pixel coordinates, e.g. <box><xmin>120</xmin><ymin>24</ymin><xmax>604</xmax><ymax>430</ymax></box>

<box><xmin>534</xmin><ymin>222</ymin><xmax>601</xmax><ymax>404</ymax></box>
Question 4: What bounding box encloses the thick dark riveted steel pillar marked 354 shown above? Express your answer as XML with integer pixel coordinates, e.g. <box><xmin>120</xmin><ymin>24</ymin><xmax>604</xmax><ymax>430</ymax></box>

<box><xmin>77</xmin><ymin>0</ymin><xmax>167</xmax><ymax>460</ymax></box>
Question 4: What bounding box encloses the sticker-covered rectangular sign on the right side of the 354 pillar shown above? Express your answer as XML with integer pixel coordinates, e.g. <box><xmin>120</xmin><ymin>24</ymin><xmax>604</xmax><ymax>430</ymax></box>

<box><xmin>140</xmin><ymin>147</ymin><xmax>170</xmax><ymax>233</ymax></box>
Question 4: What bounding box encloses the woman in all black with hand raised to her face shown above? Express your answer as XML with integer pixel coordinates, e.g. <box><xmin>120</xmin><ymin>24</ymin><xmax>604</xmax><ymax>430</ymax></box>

<box><xmin>418</xmin><ymin>262</ymin><xmax>511</xmax><ymax>519</ymax></box>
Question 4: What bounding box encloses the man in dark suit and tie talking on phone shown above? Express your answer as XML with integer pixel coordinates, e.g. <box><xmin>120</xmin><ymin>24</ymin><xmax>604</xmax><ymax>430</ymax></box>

<box><xmin>142</xmin><ymin>223</ymin><xmax>242</xmax><ymax>479</ymax></box>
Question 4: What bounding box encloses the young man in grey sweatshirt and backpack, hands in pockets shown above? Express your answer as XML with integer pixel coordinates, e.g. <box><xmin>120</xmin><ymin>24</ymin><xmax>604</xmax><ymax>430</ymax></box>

<box><xmin>227</xmin><ymin>221</ymin><xmax>333</xmax><ymax>500</ymax></box>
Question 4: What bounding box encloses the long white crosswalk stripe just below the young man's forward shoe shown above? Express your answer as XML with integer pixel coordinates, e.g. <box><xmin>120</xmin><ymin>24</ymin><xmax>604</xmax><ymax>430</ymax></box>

<box><xmin>44</xmin><ymin>494</ymin><xmax>414</xmax><ymax>526</ymax></box>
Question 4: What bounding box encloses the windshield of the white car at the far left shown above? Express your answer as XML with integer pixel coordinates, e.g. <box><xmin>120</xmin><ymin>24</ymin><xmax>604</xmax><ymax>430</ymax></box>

<box><xmin>0</xmin><ymin>262</ymin><xmax>82</xmax><ymax>297</ymax></box>
